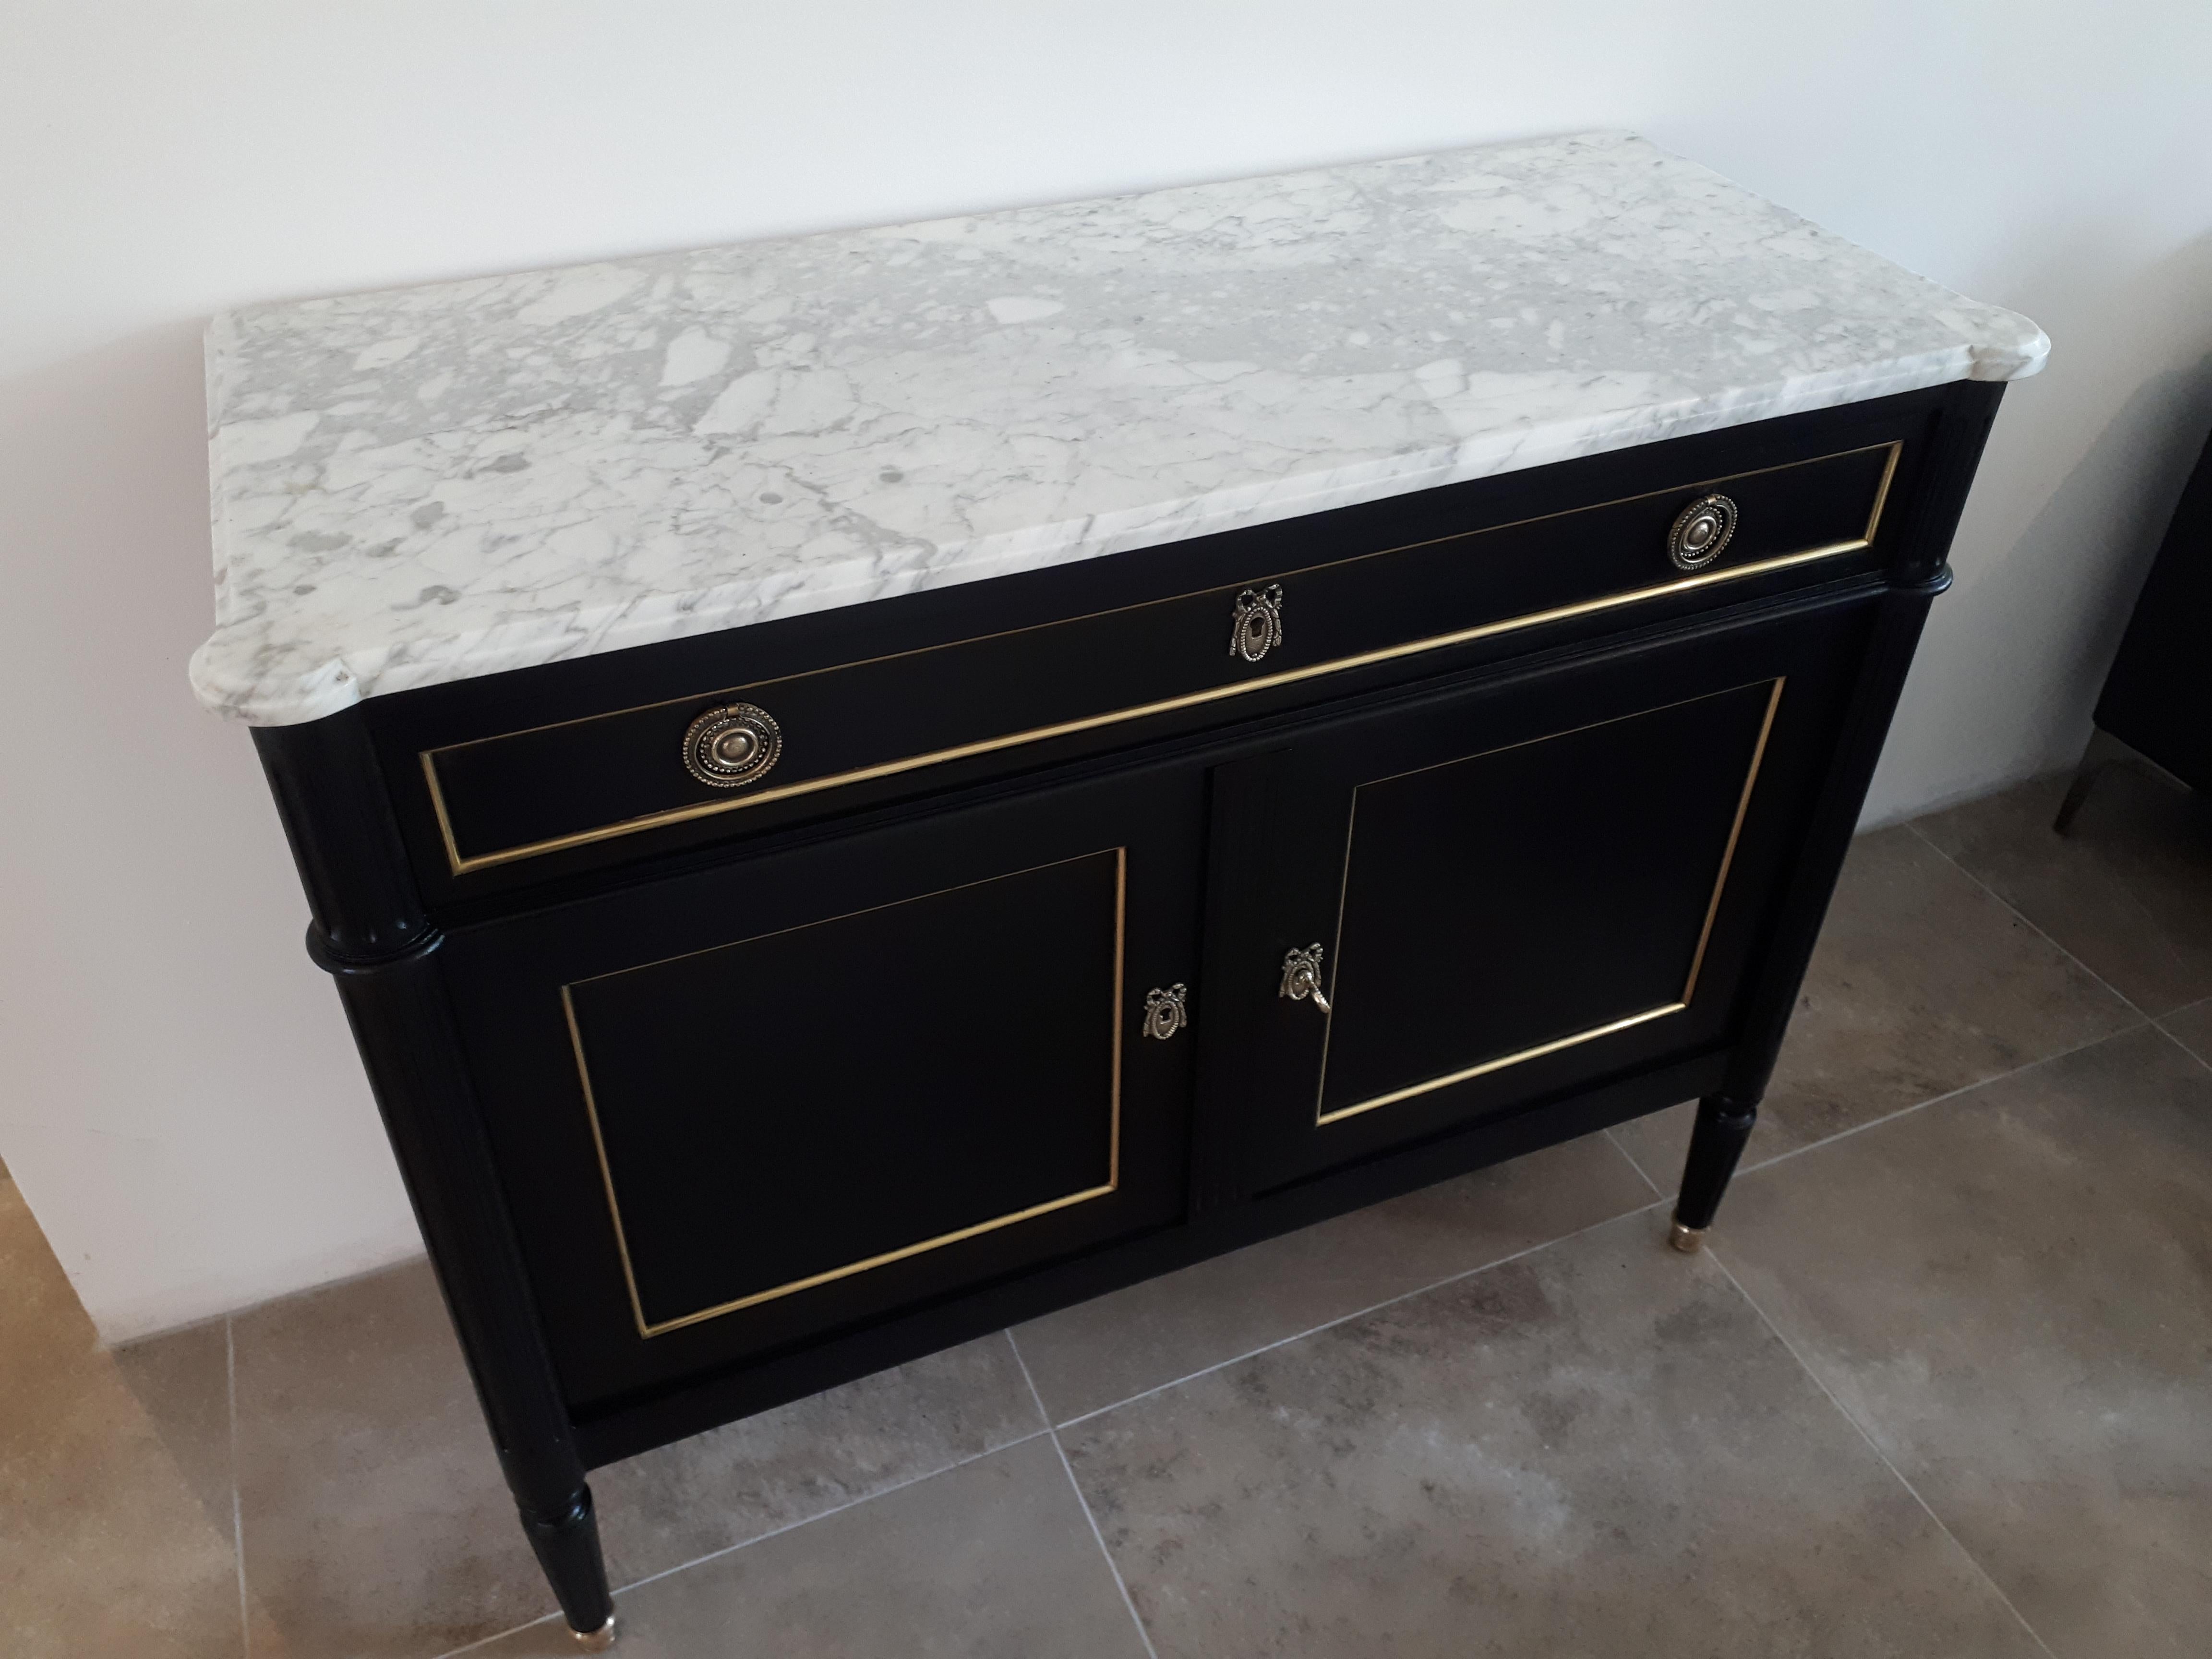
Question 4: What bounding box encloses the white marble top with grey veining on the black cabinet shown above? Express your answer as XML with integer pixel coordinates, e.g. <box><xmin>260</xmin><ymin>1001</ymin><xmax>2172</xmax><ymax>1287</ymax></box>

<box><xmin>192</xmin><ymin>132</ymin><xmax>2048</xmax><ymax>725</ymax></box>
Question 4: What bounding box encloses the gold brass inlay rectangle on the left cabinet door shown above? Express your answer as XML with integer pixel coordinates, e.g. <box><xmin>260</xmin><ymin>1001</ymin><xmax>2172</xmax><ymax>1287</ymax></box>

<box><xmin>560</xmin><ymin>847</ymin><xmax>1128</xmax><ymax>1336</ymax></box>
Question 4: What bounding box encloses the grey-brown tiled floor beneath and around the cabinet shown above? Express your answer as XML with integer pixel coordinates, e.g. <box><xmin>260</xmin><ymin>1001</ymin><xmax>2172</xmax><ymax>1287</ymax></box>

<box><xmin>0</xmin><ymin>774</ymin><xmax>2212</xmax><ymax>1659</ymax></box>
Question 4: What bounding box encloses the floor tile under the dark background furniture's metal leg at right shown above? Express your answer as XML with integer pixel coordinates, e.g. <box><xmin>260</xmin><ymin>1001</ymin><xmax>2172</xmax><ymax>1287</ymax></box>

<box><xmin>1920</xmin><ymin>765</ymin><xmax>2212</xmax><ymax>1013</ymax></box>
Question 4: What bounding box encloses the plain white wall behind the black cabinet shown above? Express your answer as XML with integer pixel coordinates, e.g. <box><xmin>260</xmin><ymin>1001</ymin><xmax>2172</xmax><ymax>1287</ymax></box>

<box><xmin>0</xmin><ymin>0</ymin><xmax>2212</xmax><ymax>1338</ymax></box>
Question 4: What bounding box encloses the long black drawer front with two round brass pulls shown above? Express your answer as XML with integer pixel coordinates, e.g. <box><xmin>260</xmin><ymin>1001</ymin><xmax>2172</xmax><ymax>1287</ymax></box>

<box><xmin>421</xmin><ymin>443</ymin><xmax>1900</xmax><ymax>876</ymax></box>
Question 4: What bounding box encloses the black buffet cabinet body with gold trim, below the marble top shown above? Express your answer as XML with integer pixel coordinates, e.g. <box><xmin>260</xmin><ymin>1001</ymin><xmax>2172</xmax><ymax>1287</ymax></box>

<box><xmin>254</xmin><ymin>383</ymin><xmax>2002</xmax><ymax>1641</ymax></box>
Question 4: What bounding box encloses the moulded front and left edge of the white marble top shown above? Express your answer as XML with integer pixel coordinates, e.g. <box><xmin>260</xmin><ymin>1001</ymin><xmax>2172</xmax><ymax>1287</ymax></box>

<box><xmin>190</xmin><ymin>135</ymin><xmax>2048</xmax><ymax>725</ymax></box>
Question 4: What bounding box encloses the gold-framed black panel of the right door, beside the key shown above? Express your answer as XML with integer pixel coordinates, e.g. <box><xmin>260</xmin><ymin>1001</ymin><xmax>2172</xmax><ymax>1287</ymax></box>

<box><xmin>1316</xmin><ymin>679</ymin><xmax>1783</xmax><ymax>1124</ymax></box>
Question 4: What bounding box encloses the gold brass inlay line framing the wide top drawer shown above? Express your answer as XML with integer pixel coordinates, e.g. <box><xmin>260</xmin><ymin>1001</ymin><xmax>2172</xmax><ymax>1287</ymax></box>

<box><xmin>421</xmin><ymin>440</ymin><xmax>1904</xmax><ymax>876</ymax></box>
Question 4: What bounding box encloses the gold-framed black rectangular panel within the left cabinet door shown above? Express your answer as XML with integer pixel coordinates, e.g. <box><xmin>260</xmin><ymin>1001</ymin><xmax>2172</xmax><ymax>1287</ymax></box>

<box><xmin>562</xmin><ymin>847</ymin><xmax>1126</xmax><ymax>1336</ymax></box>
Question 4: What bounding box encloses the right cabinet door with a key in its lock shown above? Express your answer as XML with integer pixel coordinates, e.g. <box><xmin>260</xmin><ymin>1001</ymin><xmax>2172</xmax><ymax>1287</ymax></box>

<box><xmin>1203</xmin><ymin>600</ymin><xmax>1871</xmax><ymax>1190</ymax></box>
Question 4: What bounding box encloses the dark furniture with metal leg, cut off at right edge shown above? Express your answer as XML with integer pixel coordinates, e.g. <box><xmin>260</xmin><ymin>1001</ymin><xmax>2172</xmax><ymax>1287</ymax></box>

<box><xmin>2053</xmin><ymin>438</ymin><xmax>2212</xmax><ymax>834</ymax></box>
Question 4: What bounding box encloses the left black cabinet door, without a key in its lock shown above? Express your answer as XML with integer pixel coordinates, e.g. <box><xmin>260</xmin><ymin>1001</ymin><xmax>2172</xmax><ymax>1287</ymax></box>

<box><xmin>447</xmin><ymin>770</ymin><xmax>1203</xmax><ymax>1405</ymax></box>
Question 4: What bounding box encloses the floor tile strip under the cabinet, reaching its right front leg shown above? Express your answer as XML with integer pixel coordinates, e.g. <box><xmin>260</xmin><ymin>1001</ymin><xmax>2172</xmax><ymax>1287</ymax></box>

<box><xmin>1013</xmin><ymin>1135</ymin><xmax>1652</xmax><ymax>1422</ymax></box>
